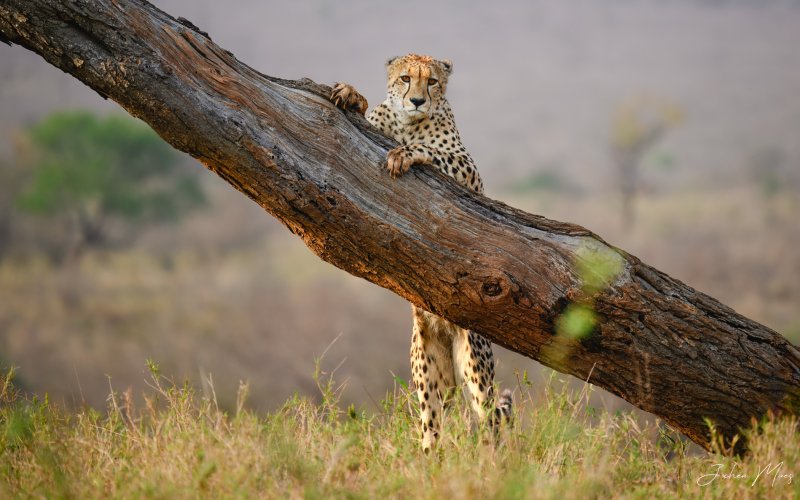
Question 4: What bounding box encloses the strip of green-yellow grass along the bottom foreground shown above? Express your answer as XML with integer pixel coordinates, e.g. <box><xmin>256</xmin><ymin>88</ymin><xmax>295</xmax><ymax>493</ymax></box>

<box><xmin>0</xmin><ymin>362</ymin><xmax>800</xmax><ymax>498</ymax></box>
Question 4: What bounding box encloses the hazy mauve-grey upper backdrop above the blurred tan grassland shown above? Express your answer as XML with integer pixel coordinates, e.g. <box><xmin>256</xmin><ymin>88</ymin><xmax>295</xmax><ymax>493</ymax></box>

<box><xmin>0</xmin><ymin>0</ymin><xmax>800</xmax><ymax>194</ymax></box>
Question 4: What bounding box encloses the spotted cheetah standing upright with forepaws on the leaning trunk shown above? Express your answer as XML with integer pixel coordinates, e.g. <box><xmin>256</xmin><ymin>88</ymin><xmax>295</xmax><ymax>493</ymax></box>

<box><xmin>330</xmin><ymin>54</ymin><xmax>512</xmax><ymax>452</ymax></box>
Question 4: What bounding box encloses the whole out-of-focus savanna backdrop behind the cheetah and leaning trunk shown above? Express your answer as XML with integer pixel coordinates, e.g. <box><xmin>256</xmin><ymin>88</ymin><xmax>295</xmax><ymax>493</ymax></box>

<box><xmin>0</xmin><ymin>0</ymin><xmax>800</xmax><ymax>410</ymax></box>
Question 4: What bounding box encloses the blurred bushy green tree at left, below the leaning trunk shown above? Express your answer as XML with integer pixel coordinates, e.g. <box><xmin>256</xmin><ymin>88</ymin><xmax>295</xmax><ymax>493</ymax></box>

<box><xmin>17</xmin><ymin>111</ymin><xmax>205</xmax><ymax>253</ymax></box>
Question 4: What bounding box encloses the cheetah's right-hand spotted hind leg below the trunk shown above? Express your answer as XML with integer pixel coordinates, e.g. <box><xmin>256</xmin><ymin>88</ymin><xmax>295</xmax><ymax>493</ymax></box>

<box><xmin>453</xmin><ymin>330</ymin><xmax>513</xmax><ymax>431</ymax></box>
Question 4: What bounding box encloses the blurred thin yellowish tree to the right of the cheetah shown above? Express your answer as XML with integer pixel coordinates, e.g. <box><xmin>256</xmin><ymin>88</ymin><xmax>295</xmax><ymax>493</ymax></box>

<box><xmin>611</xmin><ymin>97</ymin><xmax>683</xmax><ymax>228</ymax></box>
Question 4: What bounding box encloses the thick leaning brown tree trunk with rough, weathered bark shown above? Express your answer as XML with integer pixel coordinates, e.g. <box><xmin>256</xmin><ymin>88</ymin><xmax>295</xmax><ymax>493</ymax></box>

<box><xmin>0</xmin><ymin>0</ymin><xmax>800</xmax><ymax>450</ymax></box>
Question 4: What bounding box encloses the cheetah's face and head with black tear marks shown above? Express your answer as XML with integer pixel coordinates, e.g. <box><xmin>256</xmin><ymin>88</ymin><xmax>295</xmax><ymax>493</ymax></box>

<box><xmin>386</xmin><ymin>54</ymin><xmax>453</xmax><ymax>122</ymax></box>
